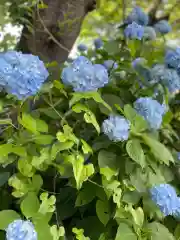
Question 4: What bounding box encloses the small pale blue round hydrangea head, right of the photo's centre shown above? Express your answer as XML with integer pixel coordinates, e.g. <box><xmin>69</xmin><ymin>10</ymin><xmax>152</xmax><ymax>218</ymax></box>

<box><xmin>102</xmin><ymin>115</ymin><xmax>130</xmax><ymax>142</ymax></box>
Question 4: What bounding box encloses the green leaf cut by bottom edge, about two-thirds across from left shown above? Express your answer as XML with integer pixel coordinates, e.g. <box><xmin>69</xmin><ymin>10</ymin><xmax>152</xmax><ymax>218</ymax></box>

<box><xmin>115</xmin><ymin>223</ymin><xmax>138</xmax><ymax>240</ymax></box>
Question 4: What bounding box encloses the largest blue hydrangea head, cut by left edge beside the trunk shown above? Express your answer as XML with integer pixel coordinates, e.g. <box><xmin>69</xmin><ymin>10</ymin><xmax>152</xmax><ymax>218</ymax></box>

<box><xmin>0</xmin><ymin>51</ymin><xmax>49</xmax><ymax>100</ymax></box>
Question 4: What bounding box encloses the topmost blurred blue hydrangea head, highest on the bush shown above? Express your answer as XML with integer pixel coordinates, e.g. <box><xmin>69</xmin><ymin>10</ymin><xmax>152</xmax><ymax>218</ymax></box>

<box><xmin>125</xmin><ymin>7</ymin><xmax>149</xmax><ymax>26</ymax></box>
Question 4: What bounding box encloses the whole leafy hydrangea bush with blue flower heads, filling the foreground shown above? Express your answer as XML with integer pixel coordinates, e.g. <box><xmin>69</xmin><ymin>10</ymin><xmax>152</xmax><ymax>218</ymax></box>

<box><xmin>0</xmin><ymin>4</ymin><xmax>180</xmax><ymax>240</ymax></box>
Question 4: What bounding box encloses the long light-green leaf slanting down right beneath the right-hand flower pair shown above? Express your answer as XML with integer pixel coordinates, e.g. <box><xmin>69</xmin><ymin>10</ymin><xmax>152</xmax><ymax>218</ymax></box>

<box><xmin>142</xmin><ymin>134</ymin><xmax>174</xmax><ymax>165</ymax></box>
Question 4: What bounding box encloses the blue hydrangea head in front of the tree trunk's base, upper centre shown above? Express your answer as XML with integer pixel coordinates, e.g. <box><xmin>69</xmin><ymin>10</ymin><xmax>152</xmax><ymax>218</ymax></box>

<box><xmin>61</xmin><ymin>56</ymin><xmax>109</xmax><ymax>92</ymax></box>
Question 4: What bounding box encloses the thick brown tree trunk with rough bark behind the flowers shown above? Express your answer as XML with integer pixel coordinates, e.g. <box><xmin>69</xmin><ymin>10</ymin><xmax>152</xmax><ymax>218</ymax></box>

<box><xmin>18</xmin><ymin>0</ymin><xmax>96</xmax><ymax>64</ymax></box>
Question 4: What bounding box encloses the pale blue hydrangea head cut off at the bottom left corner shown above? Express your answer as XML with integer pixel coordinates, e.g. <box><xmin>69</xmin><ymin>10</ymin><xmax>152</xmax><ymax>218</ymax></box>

<box><xmin>6</xmin><ymin>220</ymin><xmax>38</xmax><ymax>240</ymax></box>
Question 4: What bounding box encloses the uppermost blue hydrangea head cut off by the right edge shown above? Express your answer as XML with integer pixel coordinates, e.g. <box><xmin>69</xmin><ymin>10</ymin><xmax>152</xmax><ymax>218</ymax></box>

<box><xmin>165</xmin><ymin>47</ymin><xmax>180</xmax><ymax>72</ymax></box>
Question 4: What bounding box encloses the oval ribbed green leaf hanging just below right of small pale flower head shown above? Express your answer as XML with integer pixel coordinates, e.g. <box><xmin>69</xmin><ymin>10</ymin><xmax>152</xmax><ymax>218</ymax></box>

<box><xmin>126</xmin><ymin>139</ymin><xmax>146</xmax><ymax>168</ymax></box>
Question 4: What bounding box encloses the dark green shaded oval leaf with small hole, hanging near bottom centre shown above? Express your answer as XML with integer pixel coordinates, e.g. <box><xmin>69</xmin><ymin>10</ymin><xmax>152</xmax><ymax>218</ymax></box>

<box><xmin>96</xmin><ymin>200</ymin><xmax>110</xmax><ymax>225</ymax></box>
